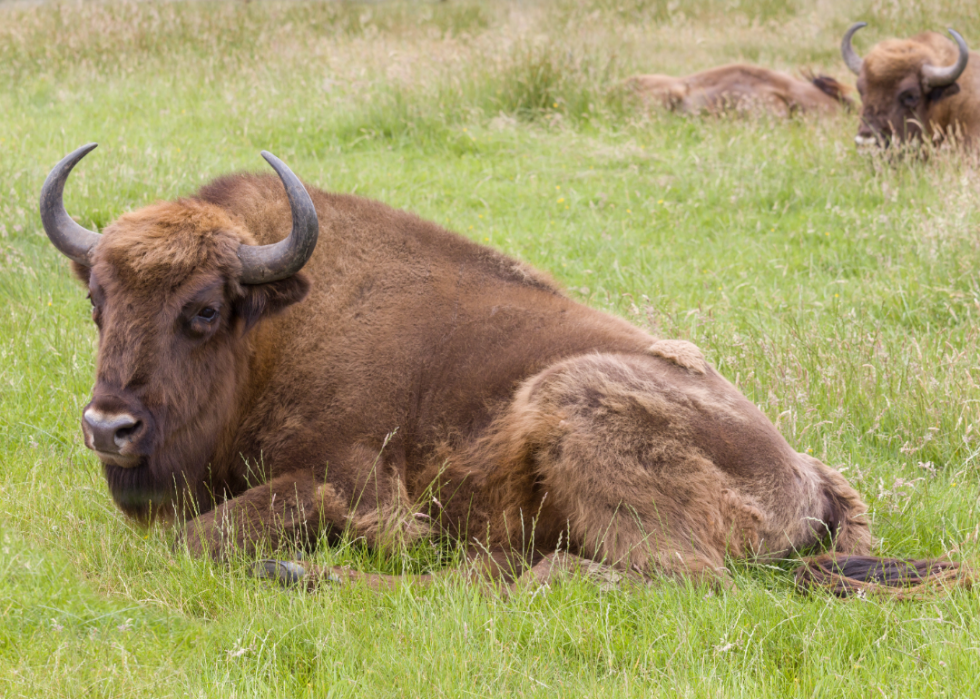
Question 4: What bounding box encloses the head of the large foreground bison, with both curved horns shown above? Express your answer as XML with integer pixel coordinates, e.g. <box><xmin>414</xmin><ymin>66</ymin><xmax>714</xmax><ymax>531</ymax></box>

<box><xmin>41</xmin><ymin>144</ymin><xmax>319</xmax><ymax>520</ymax></box>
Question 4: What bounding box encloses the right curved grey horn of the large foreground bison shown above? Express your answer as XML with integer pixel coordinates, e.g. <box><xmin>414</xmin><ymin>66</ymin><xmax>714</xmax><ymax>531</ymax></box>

<box><xmin>238</xmin><ymin>151</ymin><xmax>320</xmax><ymax>284</ymax></box>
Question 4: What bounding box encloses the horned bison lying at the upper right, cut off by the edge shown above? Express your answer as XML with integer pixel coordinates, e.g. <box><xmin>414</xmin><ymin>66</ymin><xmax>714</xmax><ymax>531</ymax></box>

<box><xmin>841</xmin><ymin>22</ymin><xmax>980</xmax><ymax>148</ymax></box>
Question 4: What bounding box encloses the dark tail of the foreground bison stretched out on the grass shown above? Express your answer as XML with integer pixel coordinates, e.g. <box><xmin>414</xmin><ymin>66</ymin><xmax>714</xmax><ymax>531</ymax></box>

<box><xmin>796</xmin><ymin>553</ymin><xmax>974</xmax><ymax>600</ymax></box>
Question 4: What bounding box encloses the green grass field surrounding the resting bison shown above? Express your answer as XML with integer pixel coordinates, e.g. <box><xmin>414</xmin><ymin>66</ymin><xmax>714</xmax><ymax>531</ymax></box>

<box><xmin>0</xmin><ymin>0</ymin><xmax>980</xmax><ymax>697</ymax></box>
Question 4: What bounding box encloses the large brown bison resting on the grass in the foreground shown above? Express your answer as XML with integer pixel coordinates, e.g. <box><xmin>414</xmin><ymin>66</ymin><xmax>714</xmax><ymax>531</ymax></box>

<box><xmin>41</xmin><ymin>144</ymin><xmax>964</xmax><ymax>596</ymax></box>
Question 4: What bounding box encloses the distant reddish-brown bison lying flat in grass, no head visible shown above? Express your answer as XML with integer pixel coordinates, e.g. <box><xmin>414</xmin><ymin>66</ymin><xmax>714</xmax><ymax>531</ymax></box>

<box><xmin>626</xmin><ymin>64</ymin><xmax>851</xmax><ymax>117</ymax></box>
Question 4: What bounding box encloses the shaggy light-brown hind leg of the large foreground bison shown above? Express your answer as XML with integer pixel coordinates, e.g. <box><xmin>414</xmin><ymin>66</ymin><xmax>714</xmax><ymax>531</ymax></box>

<box><xmin>497</xmin><ymin>356</ymin><xmax>780</xmax><ymax>585</ymax></box>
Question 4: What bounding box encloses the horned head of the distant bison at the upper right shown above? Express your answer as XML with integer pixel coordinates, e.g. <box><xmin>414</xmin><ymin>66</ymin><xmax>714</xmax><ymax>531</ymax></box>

<box><xmin>841</xmin><ymin>22</ymin><xmax>970</xmax><ymax>145</ymax></box>
